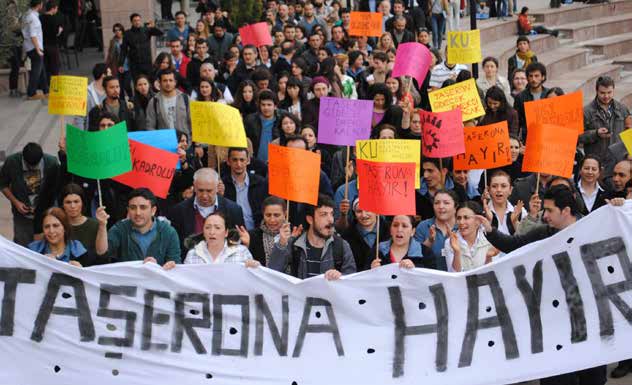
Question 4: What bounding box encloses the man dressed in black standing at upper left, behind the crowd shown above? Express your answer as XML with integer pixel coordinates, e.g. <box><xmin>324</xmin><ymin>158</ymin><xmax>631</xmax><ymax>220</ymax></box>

<box><xmin>119</xmin><ymin>13</ymin><xmax>162</xmax><ymax>79</ymax></box>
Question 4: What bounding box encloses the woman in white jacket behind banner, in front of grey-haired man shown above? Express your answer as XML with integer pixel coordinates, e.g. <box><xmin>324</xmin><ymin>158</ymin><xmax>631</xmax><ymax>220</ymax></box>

<box><xmin>184</xmin><ymin>211</ymin><xmax>259</xmax><ymax>267</ymax></box>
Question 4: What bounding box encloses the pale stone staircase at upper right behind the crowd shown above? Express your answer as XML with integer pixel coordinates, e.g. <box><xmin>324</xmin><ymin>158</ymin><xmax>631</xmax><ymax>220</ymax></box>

<box><xmin>479</xmin><ymin>0</ymin><xmax>632</xmax><ymax>108</ymax></box>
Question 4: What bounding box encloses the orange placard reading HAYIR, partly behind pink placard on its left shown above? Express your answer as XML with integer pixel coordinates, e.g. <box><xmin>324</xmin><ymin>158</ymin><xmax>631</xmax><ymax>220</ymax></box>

<box><xmin>454</xmin><ymin>120</ymin><xmax>511</xmax><ymax>170</ymax></box>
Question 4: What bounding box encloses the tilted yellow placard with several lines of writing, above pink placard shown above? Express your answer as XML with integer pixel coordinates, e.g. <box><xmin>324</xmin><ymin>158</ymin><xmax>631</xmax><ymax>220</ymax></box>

<box><xmin>428</xmin><ymin>79</ymin><xmax>485</xmax><ymax>122</ymax></box>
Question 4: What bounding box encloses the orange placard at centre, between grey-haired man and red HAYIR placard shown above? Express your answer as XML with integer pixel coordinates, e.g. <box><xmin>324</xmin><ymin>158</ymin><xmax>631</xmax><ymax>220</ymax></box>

<box><xmin>268</xmin><ymin>144</ymin><xmax>320</xmax><ymax>205</ymax></box>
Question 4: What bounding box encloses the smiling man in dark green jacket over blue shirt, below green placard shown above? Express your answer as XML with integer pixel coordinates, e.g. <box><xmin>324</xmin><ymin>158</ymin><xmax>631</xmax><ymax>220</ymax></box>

<box><xmin>96</xmin><ymin>188</ymin><xmax>182</xmax><ymax>270</ymax></box>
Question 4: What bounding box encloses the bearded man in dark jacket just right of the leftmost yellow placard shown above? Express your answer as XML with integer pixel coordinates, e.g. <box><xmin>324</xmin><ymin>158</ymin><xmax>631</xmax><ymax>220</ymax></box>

<box><xmin>88</xmin><ymin>76</ymin><xmax>134</xmax><ymax>131</ymax></box>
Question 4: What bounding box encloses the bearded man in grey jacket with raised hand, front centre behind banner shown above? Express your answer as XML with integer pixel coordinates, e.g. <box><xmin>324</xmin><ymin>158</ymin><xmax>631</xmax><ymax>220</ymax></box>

<box><xmin>269</xmin><ymin>194</ymin><xmax>356</xmax><ymax>280</ymax></box>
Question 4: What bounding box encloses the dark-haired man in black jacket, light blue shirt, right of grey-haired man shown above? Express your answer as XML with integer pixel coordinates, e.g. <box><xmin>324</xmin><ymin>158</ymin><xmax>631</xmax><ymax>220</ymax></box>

<box><xmin>222</xmin><ymin>147</ymin><xmax>268</xmax><ymax>230</ymax></box>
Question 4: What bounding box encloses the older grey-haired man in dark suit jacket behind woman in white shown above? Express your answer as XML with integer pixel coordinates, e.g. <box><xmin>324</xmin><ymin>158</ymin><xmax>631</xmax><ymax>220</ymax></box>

<box><xmin>169</xmin><ymin>167</ymin><xmax>244</xmax><ymax>255</ymax></box>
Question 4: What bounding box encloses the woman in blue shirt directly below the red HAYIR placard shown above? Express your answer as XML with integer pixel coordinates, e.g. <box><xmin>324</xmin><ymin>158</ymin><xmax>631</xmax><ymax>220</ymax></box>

<box><xmin>371</xmin><ymin>215</ymin><xmax>435</xmax><ymax>269</ymax></box>
